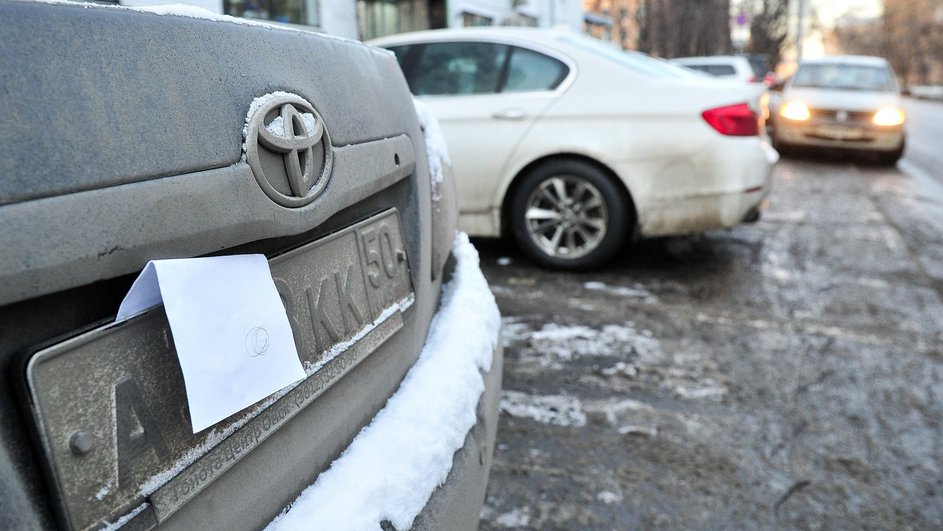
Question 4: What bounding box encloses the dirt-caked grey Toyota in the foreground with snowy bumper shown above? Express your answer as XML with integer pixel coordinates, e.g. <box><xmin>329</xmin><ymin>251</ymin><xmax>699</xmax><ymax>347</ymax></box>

<box><xmin>0</xmin><ymin>1</ymin><xmax>501</xmax><ymax>530</ymax></box>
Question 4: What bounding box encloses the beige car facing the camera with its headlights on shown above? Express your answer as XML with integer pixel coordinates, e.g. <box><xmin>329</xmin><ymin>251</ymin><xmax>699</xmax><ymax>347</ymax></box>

<box><xmin>773</xmin><ymin>56</ymin><xmax>906</xmax><ymax>163</ymax></box>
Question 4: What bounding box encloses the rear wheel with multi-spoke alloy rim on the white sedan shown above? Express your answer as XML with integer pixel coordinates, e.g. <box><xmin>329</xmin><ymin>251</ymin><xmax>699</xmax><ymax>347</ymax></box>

<box><xmin>510</xmin><ymin>160</ymin><xmax>628</xmax><ymax>270</ymax></box>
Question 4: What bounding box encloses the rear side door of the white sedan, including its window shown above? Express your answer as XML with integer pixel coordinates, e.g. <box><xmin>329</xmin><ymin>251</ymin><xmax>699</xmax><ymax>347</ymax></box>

<box><xmin>391</xmin><ymin>41</ymin><xmax>573</xmax><ymax>227</ymax></box>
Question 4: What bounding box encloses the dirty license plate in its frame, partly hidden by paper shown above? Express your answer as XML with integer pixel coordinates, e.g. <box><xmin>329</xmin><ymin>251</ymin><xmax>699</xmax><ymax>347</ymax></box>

<box><xmin>27</xmin><ymin>209</ymin><xmax>413</xmax><ymax>529</ymax></box>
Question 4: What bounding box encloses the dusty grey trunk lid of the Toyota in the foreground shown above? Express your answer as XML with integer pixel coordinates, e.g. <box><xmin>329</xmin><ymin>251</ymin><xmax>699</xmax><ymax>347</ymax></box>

<box><xmin>0</xmin><ymin>2</ymin><xmax>438</xmax><ymax>529</ymax></box>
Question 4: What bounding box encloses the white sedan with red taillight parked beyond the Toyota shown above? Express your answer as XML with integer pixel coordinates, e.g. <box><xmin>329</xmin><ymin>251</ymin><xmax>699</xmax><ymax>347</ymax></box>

<box><xmin>372</xmin><ymin>28</ymin><xmax>778</xmax><ymax>268</ymax></box>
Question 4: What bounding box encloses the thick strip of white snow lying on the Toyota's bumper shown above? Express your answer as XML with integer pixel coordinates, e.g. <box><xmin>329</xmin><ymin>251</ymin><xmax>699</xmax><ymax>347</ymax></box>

<box><xmin>267</xmin><ymin>234</ymin><xmax>501</xmax><ymax>530</ymax></box>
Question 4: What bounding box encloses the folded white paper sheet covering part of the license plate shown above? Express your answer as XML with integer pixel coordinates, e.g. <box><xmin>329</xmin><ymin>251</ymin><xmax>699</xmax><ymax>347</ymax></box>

<box><xmin>118</xmin><ymin>254</ymin><xmax>305</xmax><ymax>433</ymax></box>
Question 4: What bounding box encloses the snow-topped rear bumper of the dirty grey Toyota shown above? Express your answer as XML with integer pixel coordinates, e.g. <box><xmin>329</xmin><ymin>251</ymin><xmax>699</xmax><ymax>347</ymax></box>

<box><xmin>268</xmin><ymin>236</ymin><xmax>503</xmax><ymax>530</ymax></box>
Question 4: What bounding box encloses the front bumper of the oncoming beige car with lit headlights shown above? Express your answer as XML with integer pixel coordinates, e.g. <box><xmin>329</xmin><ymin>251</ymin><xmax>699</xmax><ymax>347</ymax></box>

<box><xmin>775</xmin><ymin>119</ymin><xmax>904</xmax><ymax>152</ymax></box>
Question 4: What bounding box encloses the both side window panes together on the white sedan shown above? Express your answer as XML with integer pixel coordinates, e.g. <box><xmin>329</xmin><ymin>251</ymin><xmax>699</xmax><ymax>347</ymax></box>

<box><xmin>390</xmin><ymin>42</ymin><xmax>570</xmax><ymax>96</ymax></box>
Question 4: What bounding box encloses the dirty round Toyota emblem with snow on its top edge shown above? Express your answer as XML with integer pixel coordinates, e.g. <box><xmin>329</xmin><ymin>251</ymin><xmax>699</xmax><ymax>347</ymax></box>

<box><xmin>245</xmin><ymin>92</ymin><xmax>334</xmax><ymax>207</ymax></box>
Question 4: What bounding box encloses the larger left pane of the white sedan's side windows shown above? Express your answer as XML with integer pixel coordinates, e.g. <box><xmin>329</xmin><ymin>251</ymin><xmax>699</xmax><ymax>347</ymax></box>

<box><xmin>408</xmin><ymin>42</ymin><xmax>508</xmax><ymax>96</ymax></box>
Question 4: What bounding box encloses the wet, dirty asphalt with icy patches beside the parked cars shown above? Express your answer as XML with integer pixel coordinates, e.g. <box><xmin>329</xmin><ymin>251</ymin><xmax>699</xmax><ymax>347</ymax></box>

<box><xmin>474</xmin><ymin>155</ymin><xmax>943</xmax><ymax>529</ymax></box>
